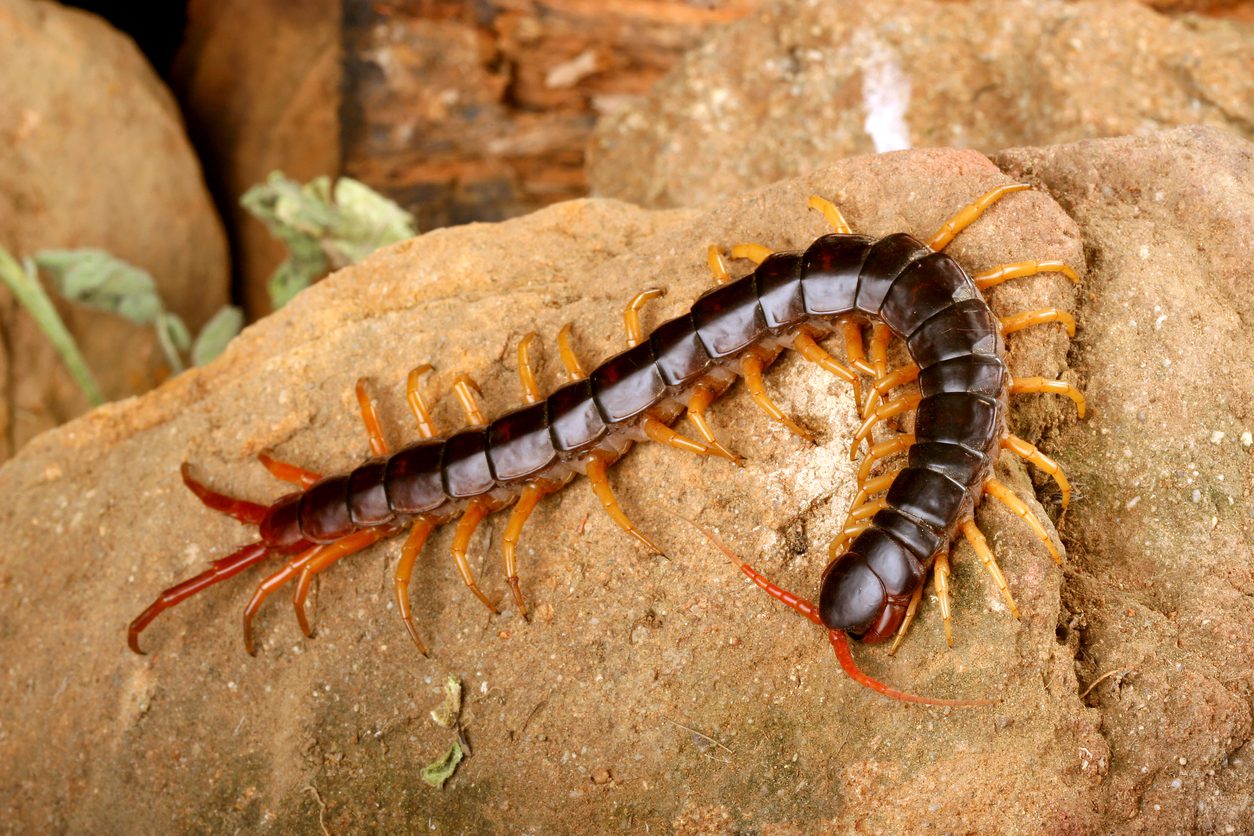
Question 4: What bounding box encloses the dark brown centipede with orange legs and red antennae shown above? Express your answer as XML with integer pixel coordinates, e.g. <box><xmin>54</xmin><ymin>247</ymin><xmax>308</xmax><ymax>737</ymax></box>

<box><xmin>127</xmin><ymin>183</ymin><xmax>1085</xmax><ymax>706</ymax></box>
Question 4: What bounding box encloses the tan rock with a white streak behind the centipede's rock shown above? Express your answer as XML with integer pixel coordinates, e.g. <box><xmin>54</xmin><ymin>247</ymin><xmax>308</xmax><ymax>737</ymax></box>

<box><xmin>588</xmin><ymin>0</ymin><xmax>1254</xmax><ymax>207</ymax></box>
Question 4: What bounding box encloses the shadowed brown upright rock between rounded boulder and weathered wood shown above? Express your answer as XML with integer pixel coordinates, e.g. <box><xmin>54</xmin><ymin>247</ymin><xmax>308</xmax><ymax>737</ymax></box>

<box><xmin>174</xmin><ymin>0</ymin><xmax>344</xmax><ymax>316</ymax></box>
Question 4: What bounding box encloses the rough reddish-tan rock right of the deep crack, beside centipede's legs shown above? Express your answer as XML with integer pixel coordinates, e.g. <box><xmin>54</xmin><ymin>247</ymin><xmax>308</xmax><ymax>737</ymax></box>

<box><xmin>994</xmin><ymin>128</ymin><xmax>1254</xmax><ymax>833</ymax></box>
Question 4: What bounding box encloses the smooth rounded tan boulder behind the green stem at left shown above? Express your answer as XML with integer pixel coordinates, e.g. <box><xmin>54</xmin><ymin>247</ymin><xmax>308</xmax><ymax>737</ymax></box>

<box><xmin>0</xmin><ymin>0</ymin><xmax>228</xmax><ymax>457</ymax></box>
